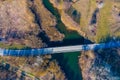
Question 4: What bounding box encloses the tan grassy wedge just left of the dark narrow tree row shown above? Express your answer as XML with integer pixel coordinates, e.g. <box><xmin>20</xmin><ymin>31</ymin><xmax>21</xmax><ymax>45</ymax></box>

<box><xmin>72</xmin><ymin>0</ymin><xmax>96</xmax><ymax>30</ymax></box>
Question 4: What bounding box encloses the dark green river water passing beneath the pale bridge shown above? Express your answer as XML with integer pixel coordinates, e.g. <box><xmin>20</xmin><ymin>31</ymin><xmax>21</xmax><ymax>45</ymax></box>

<box><xmin>43</xmin><ymin>0</ymin><xmax>84</xmax><ymax>80</ymax></box>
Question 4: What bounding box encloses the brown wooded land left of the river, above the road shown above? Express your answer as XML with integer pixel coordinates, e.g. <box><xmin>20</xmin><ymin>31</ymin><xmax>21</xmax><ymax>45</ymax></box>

<box><xmin>0</xmin><ymin>0</ymin><xmax>64</xmax><ymax>48</ymax></box>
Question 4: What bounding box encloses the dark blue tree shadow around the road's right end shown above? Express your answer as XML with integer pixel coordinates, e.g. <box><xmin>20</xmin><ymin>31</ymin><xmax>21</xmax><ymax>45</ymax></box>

<box><xmin>95</xmin><ymin>35</ymin><xmax>120</xmax><ymax>76</ymax></box>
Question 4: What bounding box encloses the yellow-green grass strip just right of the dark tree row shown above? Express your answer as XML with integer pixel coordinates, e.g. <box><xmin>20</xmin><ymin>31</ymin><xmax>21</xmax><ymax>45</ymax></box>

<box><xmin>95</xmin><ymin>0</ymin><xmax>112</xmax><ymax>42</ymax></box>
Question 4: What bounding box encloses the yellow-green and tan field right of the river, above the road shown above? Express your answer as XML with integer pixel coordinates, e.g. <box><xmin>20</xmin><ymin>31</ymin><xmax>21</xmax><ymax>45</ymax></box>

<box><xmin>72</xmin><ymin>0</ymin><xmax>120</xmax><ymax>43</ymax></box>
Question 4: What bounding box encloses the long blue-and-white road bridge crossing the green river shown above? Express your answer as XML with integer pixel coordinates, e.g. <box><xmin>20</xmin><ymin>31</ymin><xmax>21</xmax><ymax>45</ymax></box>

<box><xmin>0</xmin><ymin>41</ymin><xmax>120</xmax><ymax>56</ymax></box>
